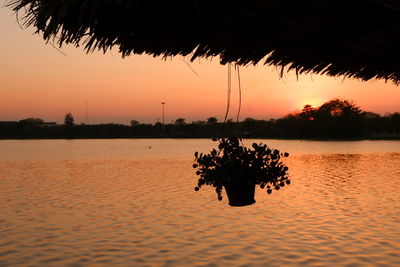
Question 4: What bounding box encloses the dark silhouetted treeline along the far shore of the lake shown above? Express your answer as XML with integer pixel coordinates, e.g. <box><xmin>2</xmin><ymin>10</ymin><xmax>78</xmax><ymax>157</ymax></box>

<box><xmin>0</xmin><ymin>99</ymin><xmax>400</xmax><ymax>139</ymax></box>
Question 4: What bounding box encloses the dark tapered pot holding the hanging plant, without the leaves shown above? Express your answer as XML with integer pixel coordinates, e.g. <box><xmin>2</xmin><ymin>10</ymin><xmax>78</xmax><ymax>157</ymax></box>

<box><xmin>224</xmin><ymin>182</ymin><xmax>256</xmax><ymax>207</ymax></box>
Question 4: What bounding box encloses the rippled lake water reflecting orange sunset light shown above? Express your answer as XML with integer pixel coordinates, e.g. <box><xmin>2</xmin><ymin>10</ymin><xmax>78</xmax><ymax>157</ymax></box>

<box><xmin>0</xmin><ymin>139</ymin><xmax>400</xmax><ymax>266</ymax></box>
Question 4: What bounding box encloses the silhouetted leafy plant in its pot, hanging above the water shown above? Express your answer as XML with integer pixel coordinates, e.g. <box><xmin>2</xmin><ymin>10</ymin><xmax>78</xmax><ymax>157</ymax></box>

<box><xmin>193</xmin><ymin>136</ymin><xmax>290</xmax><ymax>206</ymax></box>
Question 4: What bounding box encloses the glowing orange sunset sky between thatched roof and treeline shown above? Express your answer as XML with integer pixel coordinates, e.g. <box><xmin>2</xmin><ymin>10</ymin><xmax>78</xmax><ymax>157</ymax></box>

<box><xmin>0</xmin><ymin>5</ymin><xmax>400</xmax><ymax>124</ymax></box>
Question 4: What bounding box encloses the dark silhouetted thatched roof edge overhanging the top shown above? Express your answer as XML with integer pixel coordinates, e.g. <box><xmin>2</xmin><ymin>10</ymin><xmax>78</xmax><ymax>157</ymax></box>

<box><xmin>10</xmin><ymin>0</ymin><xmax>400</xmax><ymax>83</ymax></box>
